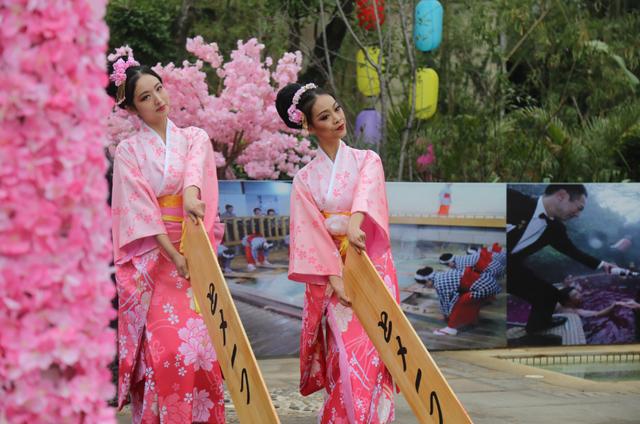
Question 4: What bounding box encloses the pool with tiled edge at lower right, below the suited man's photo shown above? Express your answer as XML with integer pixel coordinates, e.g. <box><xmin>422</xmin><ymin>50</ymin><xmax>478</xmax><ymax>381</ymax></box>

<box><xmin>501</xmin><ymin>352</ymin><xmax>640</xmax><ymax>381</ymax></box>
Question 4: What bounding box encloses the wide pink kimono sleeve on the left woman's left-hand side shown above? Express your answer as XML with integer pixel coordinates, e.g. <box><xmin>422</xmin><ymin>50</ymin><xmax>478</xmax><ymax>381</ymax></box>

<box><xmin>111</xmin><ymin>141</ymin><xmax>167</xmax><ymax>264</ymax></box>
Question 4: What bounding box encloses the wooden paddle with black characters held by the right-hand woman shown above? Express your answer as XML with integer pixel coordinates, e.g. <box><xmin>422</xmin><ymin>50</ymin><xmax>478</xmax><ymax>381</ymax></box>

<box><xmin>343</xmin><ymin>246</ymin><xmax>472</xmax><ymax>424</ymax></box>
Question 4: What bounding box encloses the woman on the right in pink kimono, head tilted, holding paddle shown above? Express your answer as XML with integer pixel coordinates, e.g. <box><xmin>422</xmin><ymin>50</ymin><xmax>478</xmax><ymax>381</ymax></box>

<box><xmin>276</xmin><ymin>84</ymin><xmax>399</xmax><ymax>424</ymax></box>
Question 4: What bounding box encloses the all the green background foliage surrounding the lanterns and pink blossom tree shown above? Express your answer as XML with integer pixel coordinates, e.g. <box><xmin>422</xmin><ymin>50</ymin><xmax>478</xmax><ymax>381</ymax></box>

<box><xmin>107</xmin><ymin>0</ymin><xmax>640</xmax><ymax>181</ymax></box>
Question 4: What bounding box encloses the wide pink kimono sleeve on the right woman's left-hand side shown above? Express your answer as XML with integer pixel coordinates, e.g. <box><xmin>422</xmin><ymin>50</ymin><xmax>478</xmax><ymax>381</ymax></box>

<box><xmin>289</xmin><ymin>175</ymin><xmax>343</xmax><ymax>284</ymax></box>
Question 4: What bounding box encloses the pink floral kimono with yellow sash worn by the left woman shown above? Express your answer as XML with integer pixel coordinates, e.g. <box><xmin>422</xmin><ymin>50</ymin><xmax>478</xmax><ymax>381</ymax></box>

<box><xmin>112</xmin><ymin>121</ymin><xmax>225</xmax><ymax>424</ymax></box>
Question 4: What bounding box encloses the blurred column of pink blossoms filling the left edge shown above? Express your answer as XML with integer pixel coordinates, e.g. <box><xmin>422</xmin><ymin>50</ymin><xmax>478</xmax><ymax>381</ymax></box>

<box><xmin>0</xmin><ymin>0</ymin><xmax>115</xmax><ymax>423</ymax></box>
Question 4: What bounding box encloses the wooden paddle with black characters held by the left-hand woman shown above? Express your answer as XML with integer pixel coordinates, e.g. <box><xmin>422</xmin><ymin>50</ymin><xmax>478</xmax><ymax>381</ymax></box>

<box><xmin>184</xmin><ymin>219</ymin><xmax>280</xmax><ymax>424</ymax></box>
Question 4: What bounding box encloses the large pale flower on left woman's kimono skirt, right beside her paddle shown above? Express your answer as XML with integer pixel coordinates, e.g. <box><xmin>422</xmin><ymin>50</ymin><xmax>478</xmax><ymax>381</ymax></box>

<box><xmin>178</xmin><ymin>318</ymin><xmax>216</xmax><ymax>371</ymax></box>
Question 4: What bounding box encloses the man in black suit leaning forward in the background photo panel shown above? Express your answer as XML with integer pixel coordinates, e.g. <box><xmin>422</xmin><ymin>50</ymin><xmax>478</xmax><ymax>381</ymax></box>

<box><xmin>507</xmin><ymin>184</ymin><xmax>615</xmax><ymax>344</ymax></box>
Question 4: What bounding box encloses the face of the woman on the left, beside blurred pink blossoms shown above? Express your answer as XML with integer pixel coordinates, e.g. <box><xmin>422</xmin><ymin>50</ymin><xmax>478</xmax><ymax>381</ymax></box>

<box><xmin>133</xmin><ymin>74</ymin><xmax>169</xmax><ymax>124</ymax></box>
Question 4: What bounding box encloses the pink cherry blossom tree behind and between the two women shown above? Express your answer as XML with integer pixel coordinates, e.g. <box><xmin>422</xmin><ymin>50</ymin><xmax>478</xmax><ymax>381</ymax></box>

<box><xmin>108</xmin><ymin>37</ymin><xmax>314</xmax><ymax>179</ymax></box>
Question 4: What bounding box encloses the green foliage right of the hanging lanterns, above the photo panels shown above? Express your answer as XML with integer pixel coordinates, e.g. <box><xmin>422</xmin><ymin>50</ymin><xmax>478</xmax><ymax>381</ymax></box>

<box><xmin>404</xmin><ymin>0</ymin><xmax>640</xmax><ymax>181</ymax></box>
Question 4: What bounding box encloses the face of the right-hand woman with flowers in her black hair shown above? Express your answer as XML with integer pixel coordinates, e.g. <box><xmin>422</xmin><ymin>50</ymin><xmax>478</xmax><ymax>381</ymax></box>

<box><xmin>309</xmin><ymin>94</ymin><xmax>347</xmax><ymax>141</ymax></box>
